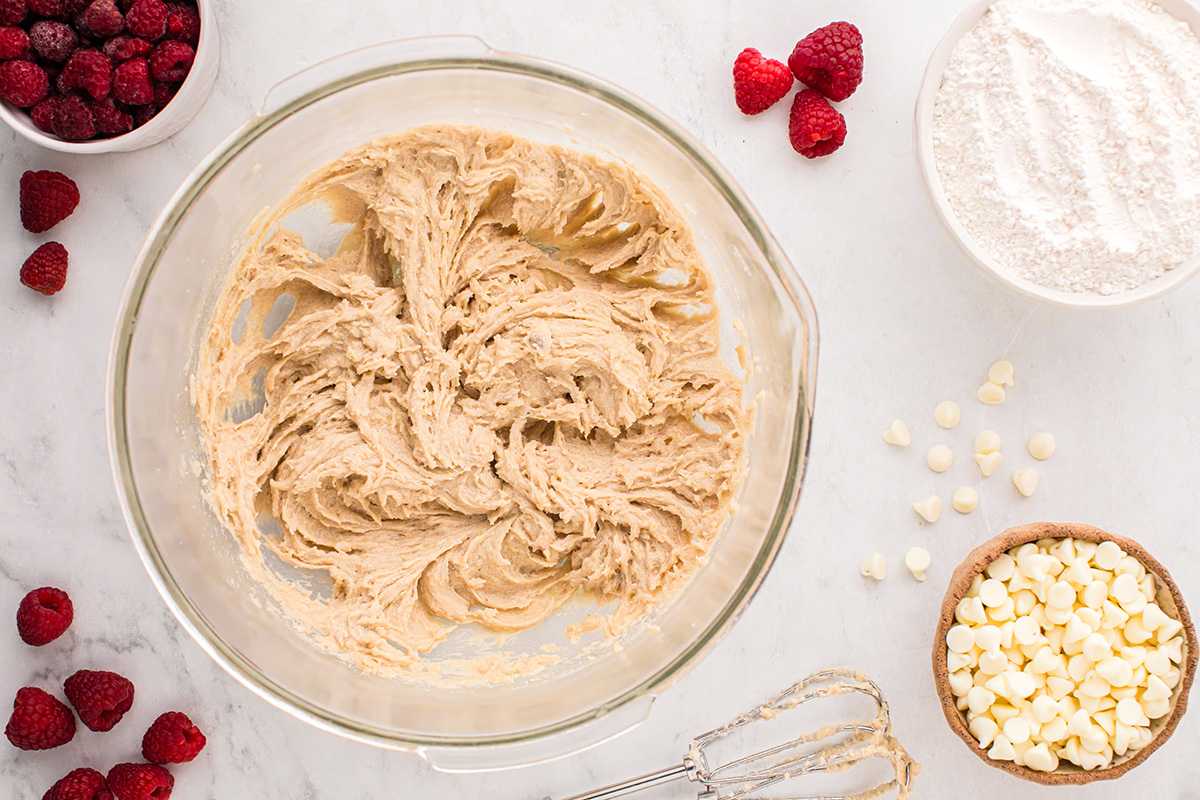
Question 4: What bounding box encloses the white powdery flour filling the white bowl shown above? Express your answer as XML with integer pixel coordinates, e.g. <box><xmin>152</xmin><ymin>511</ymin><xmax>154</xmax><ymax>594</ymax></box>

<box><xmin>934</xmin><ymin>0</ymin><xmax>1200</xmax><ymax>295</ymax></box>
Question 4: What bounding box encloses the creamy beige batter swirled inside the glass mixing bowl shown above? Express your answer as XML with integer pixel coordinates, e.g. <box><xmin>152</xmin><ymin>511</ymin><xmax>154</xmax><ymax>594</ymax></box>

<box><xmin>193</xmin><ymin>126</ymin><xmax>750</xmax><ymax>674</ymax></box>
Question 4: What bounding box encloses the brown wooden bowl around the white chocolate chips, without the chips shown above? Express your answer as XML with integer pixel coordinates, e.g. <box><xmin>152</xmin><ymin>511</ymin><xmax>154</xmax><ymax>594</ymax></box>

<box><xmin>934</xmin><ymin>522</ymin><xmax>1200</xmax><ymax>786</ymax></box>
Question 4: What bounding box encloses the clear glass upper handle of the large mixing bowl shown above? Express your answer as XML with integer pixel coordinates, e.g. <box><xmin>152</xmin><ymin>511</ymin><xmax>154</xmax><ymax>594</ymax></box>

<box><xmin>258</xmin><ymin>35</ymin><xmax>494</xmax><ymax>116</ymax></box>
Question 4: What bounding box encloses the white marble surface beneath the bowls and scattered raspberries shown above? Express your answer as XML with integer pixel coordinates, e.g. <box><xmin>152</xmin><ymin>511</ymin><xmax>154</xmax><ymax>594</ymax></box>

<box><xmin>0</xmin><ymin>0</ymin><xmax>1200</xmax><ymax>800</ymax></box>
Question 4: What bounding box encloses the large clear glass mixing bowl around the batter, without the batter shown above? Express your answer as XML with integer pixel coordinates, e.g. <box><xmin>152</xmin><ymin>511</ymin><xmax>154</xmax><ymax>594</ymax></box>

<box><xmin>108</xmin><ymin>37</ymin><xmax>817</xmax><ymax>770</ymax></box>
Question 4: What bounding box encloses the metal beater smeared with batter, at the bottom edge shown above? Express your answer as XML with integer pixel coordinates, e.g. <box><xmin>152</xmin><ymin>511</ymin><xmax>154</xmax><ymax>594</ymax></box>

<box><xmin>547</xmin><ymin>669</ymin><xmax>919</xmax><ymax>800</ymax></box>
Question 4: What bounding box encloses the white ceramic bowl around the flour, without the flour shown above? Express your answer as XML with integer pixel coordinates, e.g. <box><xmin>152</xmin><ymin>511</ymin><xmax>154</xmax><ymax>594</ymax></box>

<box><xmin>916</xmin><ymin>0</ymin><xmax>1200</xmax><ymax>308</ymax></box>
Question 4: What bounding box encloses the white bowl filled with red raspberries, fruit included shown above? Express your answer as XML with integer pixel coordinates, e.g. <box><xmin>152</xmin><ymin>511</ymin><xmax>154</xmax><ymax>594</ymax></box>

<box><xmin>0</xmin><ymin>0</ymin><xmax>220</xmax><ymax>152</ymax></box>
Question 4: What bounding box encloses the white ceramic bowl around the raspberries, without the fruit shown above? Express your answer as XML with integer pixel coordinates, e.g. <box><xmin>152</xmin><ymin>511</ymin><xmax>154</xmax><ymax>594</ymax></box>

<box><xmin>0</xmin><ymin>0</ymin><xmax>221</xmax><ymax>154</ymax></box>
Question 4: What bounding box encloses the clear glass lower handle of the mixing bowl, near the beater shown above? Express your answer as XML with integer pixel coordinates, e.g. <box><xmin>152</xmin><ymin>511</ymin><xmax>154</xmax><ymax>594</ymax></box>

<box><xmin>418</xmin><ymin>694</ymin><xmax>654</xmax><ymax>772</ymax></box>
